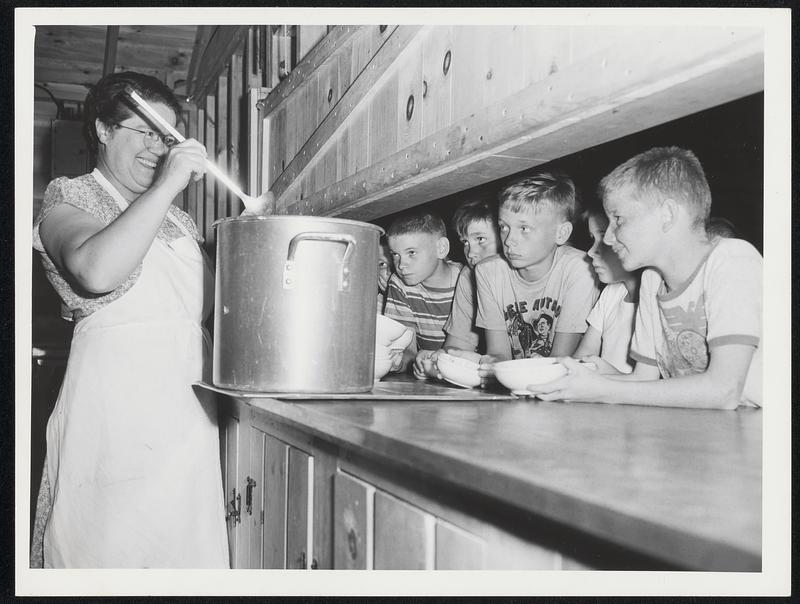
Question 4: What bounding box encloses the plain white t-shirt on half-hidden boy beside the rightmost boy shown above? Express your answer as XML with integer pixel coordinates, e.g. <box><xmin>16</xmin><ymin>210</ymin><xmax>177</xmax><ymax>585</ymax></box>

<box><xmin>586</xmin><ymin>283</ymin><xmax>636</xmax><ymax>373</ymax></box>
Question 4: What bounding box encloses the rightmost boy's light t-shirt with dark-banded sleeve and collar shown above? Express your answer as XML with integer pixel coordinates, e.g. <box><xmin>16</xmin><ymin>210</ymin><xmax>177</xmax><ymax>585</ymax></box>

<box><xmin>631</xmin><ymin>239</ymin><xmax>763</xmax><ymax>407</ymax></box>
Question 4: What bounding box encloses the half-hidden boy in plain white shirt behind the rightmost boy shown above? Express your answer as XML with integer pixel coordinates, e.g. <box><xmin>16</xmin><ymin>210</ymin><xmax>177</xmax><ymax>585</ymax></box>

<box><xmin>572</xmin><ymin>208</ymin><xmax>639</xmax><ymax>373</ymax></box>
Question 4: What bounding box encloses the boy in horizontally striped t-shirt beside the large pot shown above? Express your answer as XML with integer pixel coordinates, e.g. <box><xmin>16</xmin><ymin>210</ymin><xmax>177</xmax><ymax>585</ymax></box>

<box><xmin>383</xmin><ymin>212</ymin><xmax>461</xmax><ymax>371</ymax></box>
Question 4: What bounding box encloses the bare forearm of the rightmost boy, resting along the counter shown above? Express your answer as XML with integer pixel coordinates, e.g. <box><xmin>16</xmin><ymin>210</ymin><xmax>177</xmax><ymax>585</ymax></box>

<box><xmin>531</xmin><ymin>344</ymin><xmax>755</xmax><ymax>409</ymax></box>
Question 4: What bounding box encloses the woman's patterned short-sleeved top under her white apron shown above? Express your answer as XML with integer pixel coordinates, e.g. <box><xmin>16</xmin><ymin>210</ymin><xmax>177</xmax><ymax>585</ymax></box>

<box><xmin>33</xmin><ymin>170</ymin><xmax>202</xmax><ymax>323</ymax></box>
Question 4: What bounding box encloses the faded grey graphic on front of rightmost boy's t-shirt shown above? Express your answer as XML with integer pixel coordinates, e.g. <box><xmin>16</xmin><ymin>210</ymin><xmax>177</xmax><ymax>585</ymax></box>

<box><xmin>656</xmin><ymin>293</ymin><xmax>708</xmax><ymax>377</ymax></box>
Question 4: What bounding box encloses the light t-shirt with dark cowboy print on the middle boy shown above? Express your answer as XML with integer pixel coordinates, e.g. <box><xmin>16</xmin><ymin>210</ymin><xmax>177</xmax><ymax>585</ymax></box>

<box><xmin>475</xmin><ymin>245</ymin><xmax>599</xmax><ymax>359</ymax></box>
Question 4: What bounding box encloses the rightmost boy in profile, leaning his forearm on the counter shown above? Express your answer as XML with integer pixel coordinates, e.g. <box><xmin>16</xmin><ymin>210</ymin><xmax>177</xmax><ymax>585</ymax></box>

<box><xmin>532</xmin><ymin>147</ymin><xmax>762</xmax><ymax>409</ymax></box>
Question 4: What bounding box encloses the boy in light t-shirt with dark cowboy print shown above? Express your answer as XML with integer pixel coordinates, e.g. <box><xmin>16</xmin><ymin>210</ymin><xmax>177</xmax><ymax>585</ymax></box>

<box><xmin>475</xmin><ymin>173</ymin><xmax>598</xmax><ymax>360</ymax></box>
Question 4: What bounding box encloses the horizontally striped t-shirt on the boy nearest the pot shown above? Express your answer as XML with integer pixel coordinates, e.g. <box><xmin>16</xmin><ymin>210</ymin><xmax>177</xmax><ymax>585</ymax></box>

<box><xmin>383</xmin><ymin>260</ymin><xmax>462</xmax><ymax>350</ymax></box>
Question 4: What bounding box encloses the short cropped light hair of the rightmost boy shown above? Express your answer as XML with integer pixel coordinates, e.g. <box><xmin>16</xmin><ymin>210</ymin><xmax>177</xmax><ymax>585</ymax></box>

<box><xmin>598</xmin><ymin>147</ymin><xmax>711</xmax><ymax>226</ymax></box>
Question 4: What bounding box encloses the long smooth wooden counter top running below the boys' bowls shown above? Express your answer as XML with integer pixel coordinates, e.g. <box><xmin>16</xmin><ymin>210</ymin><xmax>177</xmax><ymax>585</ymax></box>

<box><xmin>209</xmin><ymin>378</ymin><xmax>762</xmax><ymax>571</ymax></box>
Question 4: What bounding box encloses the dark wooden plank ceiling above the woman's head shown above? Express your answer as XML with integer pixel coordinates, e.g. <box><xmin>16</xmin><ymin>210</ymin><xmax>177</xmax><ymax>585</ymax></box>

<box><xmin>33</xmin><ymin>25</ymin><xmax>197</xmax><ymax>101</ymax></box>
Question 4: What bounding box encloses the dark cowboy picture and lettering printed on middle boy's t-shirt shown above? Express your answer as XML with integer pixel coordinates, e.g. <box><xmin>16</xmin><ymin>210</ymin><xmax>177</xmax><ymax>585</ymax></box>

<box><xmin>503</xmin><ymin>297</ymin><xmax>561</xmax><ymax>359</ymax></box>
